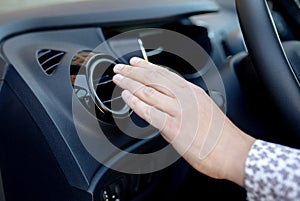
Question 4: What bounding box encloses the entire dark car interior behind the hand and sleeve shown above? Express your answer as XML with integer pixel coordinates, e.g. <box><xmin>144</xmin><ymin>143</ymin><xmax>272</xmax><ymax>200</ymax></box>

<box><xmin>0</xmin><ymin>0</ymin><xmax>300</xmax><ymax>201</ymax></box>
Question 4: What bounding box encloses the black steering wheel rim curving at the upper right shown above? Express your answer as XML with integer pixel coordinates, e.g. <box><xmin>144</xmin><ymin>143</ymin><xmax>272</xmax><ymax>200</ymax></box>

<box><xmin>236</xmin><ymin>0</ymin><xmax>300</xmax><ymax>142</ymax></box>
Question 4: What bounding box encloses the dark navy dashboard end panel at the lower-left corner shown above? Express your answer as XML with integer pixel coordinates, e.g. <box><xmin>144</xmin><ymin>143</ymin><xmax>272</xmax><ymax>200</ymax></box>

<box><xmin>0</xmin><ymin>78</ymin><xmax>91</xmax><ymax>201</ymax></box>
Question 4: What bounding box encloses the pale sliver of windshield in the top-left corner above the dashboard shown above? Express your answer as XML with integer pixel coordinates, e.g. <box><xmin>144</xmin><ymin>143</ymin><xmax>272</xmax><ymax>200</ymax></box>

<box><xmin>0</xmin><ymin>0</ymin><xmax>86</xmax><ymax>13</ymax></box>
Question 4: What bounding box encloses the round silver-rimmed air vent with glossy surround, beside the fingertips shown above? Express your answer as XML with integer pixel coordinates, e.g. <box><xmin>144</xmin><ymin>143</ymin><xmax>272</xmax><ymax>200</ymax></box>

<box><xmin>71</xmin><ymin>51</ymin><xmax>132</xmax><ymax>122</ymax></box>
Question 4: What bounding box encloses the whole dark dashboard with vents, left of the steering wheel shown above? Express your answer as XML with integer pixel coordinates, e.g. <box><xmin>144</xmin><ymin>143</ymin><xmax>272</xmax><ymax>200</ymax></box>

<box><xmin>0</xmin><ymin>0</ymin><xmax>298</xmax><ymax>201</ymax></box>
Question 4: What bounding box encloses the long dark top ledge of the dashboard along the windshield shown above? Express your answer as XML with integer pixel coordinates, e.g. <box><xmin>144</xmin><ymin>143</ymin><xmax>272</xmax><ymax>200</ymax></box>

<box><xmin>0</xmin><ymin>0</ymin><xmax>219</xmax><ymax>42</ymax></box>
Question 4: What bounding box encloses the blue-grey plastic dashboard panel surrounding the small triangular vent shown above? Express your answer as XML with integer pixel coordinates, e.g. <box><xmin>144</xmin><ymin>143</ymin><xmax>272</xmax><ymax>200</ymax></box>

<box><xmin>2</xmin><ymin>28</ymin><xmax>106</xmax><ymax>189</ymax></box>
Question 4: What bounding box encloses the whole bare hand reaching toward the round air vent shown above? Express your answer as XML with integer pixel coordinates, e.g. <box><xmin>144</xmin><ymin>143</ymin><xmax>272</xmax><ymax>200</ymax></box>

<box><xmin>113</xmin><ymin>58</ymin><xmax>254</xmax><ymax>185</ymax></box>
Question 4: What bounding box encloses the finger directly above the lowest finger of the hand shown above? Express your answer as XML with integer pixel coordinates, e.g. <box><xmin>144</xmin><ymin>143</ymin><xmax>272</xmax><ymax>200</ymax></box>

<box><xmin>113</xmin><ymin>74</ymin><xmax>178</xmax><ymax>116</ymax></box>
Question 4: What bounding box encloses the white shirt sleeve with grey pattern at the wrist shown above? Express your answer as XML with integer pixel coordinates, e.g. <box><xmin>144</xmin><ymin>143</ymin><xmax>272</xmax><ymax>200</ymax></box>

<box><xmin>244</xmin><ymin>140</ymin><xmax>300</xmax><ymax>201</ymax></box>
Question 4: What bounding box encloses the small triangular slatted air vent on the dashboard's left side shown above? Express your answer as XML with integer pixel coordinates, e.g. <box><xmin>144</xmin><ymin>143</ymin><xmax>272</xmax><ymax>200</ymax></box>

<box><xmin>37</xmin><ymin>49</ymin><xmax>65</xmax><ymax>75</ymax></box>
